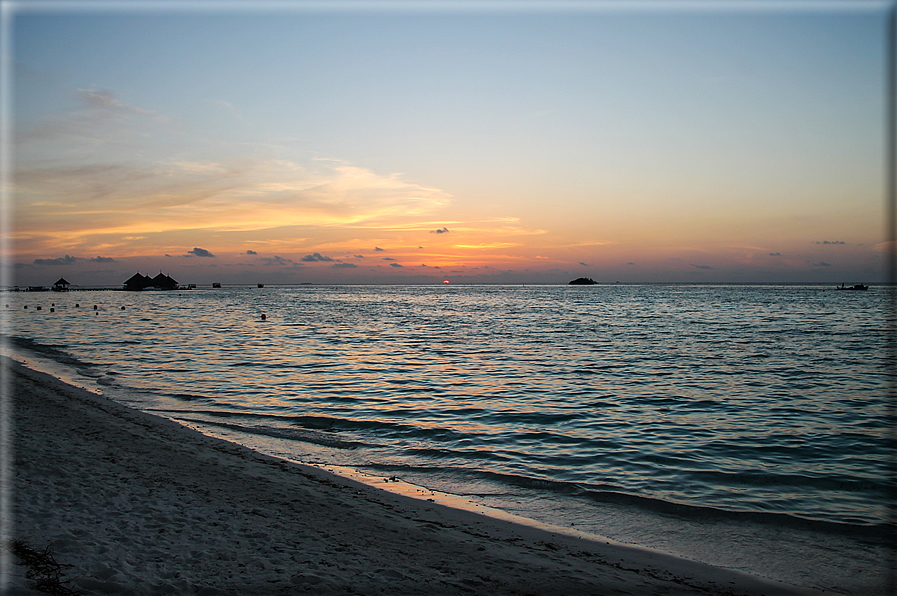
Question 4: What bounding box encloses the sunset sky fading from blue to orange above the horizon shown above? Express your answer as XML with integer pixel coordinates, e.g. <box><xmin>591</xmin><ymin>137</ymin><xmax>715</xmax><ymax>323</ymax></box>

<box><xmin>3</xmin><ymin>0</ymin><xmax>890</xmax><ymax>286</ymax></box>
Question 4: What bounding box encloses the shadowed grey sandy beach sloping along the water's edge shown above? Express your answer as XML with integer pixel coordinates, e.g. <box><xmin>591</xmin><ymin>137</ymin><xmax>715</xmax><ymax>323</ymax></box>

<box><xmin>3</xmin><ymin>358</ymin><xmax>813</xmax><ymax>596</ymax></box>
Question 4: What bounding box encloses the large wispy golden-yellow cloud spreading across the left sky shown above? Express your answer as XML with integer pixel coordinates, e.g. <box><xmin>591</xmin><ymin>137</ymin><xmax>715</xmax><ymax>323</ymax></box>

<box><xmin>13</xmin><ymin>89</ymin><xmax>451</xmax><ymax>256</ymax></box>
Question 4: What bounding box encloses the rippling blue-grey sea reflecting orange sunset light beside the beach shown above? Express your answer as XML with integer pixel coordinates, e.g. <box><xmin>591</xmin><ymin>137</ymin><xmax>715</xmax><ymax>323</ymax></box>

<box><xmin>0</xmin><ymin>284</ymin><xmax>897</xmax><ymax>594</ymax></box>
